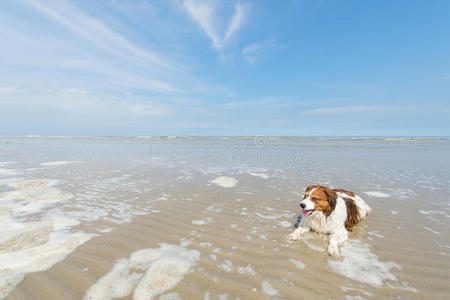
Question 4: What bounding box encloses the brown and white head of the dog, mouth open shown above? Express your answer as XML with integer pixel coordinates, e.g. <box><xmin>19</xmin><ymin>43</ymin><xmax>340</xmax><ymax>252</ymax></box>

<box><xmin>300</xmin><ymin>185</ymin><xmax>337</xmax><ymax>217</ymax></box>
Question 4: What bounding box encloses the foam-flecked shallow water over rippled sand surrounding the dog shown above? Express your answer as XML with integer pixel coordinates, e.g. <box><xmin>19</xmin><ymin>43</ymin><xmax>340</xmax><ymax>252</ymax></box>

<box><xmin>0</xmin><ymin>137</ymin><xmax>450</xmax><ymax>299</ymax></box>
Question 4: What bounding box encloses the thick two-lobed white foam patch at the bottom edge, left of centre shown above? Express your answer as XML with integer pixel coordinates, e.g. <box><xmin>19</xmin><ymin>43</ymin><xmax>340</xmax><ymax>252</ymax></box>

<box><xmin>83</xmin><ymin>243</ymin><xmax>200</xmax><ymax>300</ymax></box>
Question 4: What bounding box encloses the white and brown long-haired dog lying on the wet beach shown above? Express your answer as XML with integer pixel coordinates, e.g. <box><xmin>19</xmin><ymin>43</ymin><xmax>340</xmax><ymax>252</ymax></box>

<box><xmin>288</xmin><ymin>185</ymin><xmax>371</xmax><ymax>257</ymax></box>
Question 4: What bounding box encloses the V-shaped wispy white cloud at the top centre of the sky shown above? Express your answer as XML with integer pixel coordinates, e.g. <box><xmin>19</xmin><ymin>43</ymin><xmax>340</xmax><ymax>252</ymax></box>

<box><xmin>182</xmin><ymin>0</ymin><xmax>248</xmax><ymax>50</ymax></box>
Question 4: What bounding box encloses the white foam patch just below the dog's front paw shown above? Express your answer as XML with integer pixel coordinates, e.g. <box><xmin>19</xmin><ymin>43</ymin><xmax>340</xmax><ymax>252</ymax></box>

<box><xmin>328</xmin><ymin>240</ymin><xmax>400</xmax><ymax>287</ymax></box>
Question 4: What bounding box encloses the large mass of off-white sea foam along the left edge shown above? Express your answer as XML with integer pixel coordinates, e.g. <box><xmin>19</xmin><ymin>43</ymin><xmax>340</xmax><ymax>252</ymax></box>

<box><xmin>0</xmin><ymin>179</ymin><xmax>94</xmax><ymax>298</ymax></box>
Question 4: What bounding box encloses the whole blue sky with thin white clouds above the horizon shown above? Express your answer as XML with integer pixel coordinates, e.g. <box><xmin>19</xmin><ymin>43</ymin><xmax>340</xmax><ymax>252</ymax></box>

<box><xmin>0</xmin><ymin>0</ymin><xmax>450</xmax><ymax>136</ymax></box>
